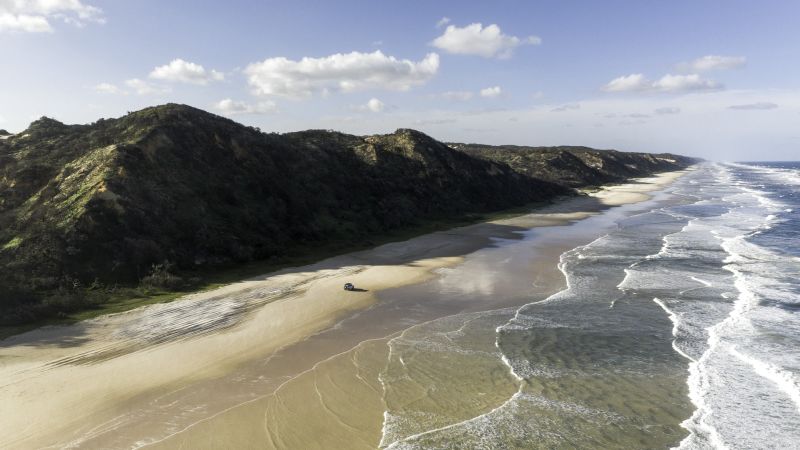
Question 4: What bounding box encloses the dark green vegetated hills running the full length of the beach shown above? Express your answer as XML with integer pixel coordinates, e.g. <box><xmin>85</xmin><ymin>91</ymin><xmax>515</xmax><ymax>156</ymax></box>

<box><xmin>0</xmin><ymin>104</ymin><xmax>689</xmax><ymax>324</ymax></box>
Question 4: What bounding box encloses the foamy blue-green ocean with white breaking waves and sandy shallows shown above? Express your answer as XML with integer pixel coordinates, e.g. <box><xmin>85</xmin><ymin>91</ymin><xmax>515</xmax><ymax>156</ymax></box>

<box><xmin>380</xmin><ymin>163</ymin><xmax>800</xmax><ymax>449</ymax></box>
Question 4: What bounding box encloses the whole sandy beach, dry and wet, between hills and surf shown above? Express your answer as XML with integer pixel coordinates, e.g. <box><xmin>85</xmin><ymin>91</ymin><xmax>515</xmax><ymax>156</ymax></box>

<box><xmin>0</xmin><ymin>172</ymin><xmax>680</xmax><ymax>448</ymax></box>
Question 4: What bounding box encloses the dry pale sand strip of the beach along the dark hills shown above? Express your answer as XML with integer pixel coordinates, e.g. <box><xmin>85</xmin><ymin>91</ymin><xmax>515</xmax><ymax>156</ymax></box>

<box><xmin>0</xmin><ymin>171</ymin><xmax>685</xmax><ymax>447</ymax></box>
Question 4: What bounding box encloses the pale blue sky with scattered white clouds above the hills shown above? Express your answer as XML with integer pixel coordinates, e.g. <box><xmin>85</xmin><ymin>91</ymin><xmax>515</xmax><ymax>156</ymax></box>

<box><xmin>0</xmin><ymin>0</ymin><xmax>800</xmax><ymax>161</ymax></box>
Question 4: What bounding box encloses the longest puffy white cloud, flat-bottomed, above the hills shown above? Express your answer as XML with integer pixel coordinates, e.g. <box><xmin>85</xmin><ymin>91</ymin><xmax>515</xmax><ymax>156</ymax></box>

<box><xmin>244</xmin><ymin>50</ymin><xmax>439</xmax><ymax>98</ymax></box>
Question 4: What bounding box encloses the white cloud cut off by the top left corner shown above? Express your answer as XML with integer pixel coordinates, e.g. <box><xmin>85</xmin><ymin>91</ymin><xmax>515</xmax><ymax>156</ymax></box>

<box><xmin>0</xmin><ymin>0</ymin><xmax>105</xmax><ymax>33</ymax></box>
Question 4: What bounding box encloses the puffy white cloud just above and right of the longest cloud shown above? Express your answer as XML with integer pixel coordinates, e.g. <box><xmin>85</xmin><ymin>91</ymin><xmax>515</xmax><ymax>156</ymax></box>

<box><xmin>431</xmin><ymin>23</ymin><xmax>542</xmax><ymax>58</ymax></box>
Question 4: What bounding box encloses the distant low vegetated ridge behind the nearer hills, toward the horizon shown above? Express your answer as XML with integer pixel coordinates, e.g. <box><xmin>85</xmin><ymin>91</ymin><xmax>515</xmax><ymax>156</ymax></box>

<box><xmin>449</xmin><ymin>144</ymin><xmax>698</xmax><ymax>188</ymax></box>
